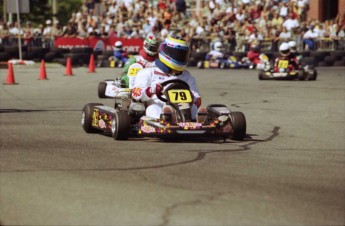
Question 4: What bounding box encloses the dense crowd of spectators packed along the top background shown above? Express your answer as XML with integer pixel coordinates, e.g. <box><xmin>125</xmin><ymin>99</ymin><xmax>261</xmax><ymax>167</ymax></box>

<box><xmin>0</xmin><ymin>0</ymin><xmax>345</xmax><ymax>51</ymax></box>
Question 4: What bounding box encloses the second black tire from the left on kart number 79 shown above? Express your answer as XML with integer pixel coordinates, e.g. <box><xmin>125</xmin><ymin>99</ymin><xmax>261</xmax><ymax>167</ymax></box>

<box><xmin>111</xmin><ymin>111</ymin><xmax>130</xmax><ymax>140</ymax></box>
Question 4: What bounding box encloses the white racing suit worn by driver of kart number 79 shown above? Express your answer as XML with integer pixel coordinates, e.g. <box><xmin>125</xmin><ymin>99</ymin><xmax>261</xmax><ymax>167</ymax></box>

<box><xmin>132</xmin><ymin>67</ymin><xmax>200</xmax><ymax>119</ymax></box>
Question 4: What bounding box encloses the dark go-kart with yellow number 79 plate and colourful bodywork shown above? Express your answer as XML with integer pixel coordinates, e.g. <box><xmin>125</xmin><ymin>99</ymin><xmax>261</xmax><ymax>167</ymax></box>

<box><xmin>81</xmin><ymin>79</ymin><xmax>246</xmax><ymax>140</ymax></box>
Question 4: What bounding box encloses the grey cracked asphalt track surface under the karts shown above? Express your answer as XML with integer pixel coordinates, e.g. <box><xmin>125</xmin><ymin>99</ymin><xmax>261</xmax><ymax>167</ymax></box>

<box><xmin>0</xmin><ymin>64</ymin><xmax>345</xmax><ymax>226</ymax></box>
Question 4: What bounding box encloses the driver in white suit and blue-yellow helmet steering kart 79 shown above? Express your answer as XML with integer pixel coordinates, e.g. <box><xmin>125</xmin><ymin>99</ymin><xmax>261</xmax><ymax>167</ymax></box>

<box><xmin>132</xmin><ymin>36</ymin><xmax>202</xmax><ymax>122</ymax></box>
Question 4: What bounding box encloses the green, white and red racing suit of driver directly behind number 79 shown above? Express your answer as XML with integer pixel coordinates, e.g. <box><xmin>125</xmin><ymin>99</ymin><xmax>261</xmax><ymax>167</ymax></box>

<box><xmin>121</xmin><ymin>49</ymin><xmax>157</xmax><ymax>88</ymax></box>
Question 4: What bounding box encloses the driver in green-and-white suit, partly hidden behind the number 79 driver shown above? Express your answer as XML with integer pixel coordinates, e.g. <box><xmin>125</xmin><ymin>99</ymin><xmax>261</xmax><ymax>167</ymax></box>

<box><xmin>121</xmin><ymin>34</ymin><xmax>159</xmax><ymax>88</ymax></box>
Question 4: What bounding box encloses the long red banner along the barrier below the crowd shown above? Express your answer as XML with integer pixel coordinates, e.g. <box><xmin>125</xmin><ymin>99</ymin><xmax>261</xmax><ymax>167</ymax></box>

<box><xmin>54</xmin><ymin>37</ymin><xmax>144</xmax><ymax>52</ymax></box>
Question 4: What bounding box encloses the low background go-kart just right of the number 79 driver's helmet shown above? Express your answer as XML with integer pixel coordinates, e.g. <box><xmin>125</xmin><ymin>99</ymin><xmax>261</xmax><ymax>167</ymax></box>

<box><xmin>196</xmin><ymin>56</ymin><xmax>242</xmax><ymax>69</ymax></box>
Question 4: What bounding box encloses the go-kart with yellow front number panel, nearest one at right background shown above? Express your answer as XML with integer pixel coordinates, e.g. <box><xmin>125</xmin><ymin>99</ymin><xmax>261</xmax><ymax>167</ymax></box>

<box><xmin>259</xmin><ymin>59</ymin><xmax>317</xmax><ymax>81</ymax></box>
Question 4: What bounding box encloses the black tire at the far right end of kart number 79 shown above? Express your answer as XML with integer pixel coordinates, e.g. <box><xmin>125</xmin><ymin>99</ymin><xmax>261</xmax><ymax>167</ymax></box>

<box><xmin>230</xmin><ymin>111</ymin><xmax>247</xmax><ymax>140</ymax></box>
